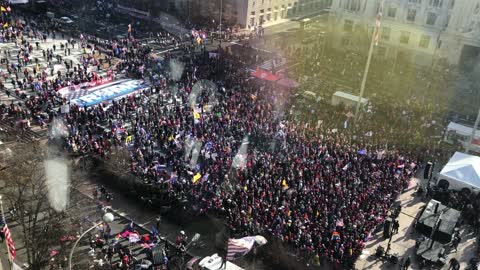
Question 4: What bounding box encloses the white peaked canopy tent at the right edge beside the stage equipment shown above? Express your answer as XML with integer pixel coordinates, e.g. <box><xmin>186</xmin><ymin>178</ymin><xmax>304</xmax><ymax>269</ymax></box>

<box><xmin>437</xmin><ymin>152</ymin><xmax>480</xmax><ymax>192</ymax></box>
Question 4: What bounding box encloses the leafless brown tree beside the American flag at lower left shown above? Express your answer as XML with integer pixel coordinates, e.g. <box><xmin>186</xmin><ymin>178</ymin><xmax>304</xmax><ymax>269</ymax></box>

<box><xmin>0</xmin><ymin>142</ymin><xmax>71</xmax><ymax>269</ymax></box>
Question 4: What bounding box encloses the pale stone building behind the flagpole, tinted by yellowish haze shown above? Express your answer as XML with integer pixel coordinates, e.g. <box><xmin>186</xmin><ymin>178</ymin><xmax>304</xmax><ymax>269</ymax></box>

<box><xmin>330</xmin><ymin>0</ymin><xmax>480</xmax><ymax>68</ymax></box>
